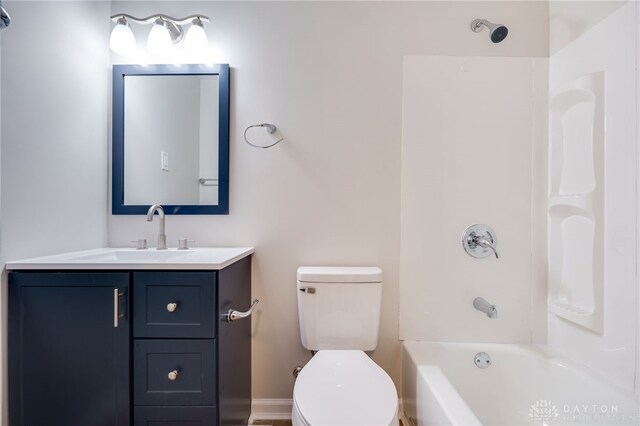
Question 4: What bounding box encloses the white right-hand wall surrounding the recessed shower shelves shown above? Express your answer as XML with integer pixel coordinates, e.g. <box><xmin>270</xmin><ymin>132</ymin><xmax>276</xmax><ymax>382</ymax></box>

<box><xmin>549</xmin><ymin>2</ymin><xmax>639</xmax><ymax>391</ymax></box>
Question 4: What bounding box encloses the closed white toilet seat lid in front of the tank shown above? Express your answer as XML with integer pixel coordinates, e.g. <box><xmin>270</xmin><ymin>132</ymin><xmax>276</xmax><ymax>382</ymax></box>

<box><xmin>292</xmin><ymin>350</ymin><xmax>398</xmax><ymax>426</ymax></box>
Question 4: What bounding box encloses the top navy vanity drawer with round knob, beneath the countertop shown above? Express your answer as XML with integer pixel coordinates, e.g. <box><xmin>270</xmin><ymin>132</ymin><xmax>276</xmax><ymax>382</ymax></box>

<box><xmin>133</xmin><ymin>271</ymin><xmax>217</xmax><ymax>338</ymax></box>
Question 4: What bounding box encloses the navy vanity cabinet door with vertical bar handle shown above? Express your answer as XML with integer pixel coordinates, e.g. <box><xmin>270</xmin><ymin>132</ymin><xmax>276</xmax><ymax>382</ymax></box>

<box><xmin>9</xmin><ymin>272</ymin><xmax>130</xmax><ymax>426</ymax></box>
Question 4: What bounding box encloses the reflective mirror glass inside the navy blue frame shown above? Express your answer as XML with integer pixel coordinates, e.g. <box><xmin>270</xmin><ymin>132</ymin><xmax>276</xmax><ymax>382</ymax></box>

<box><xmin>124</xmin><ymin>75</ymin><xmax>218</xmax><ymax>205</ymax></box>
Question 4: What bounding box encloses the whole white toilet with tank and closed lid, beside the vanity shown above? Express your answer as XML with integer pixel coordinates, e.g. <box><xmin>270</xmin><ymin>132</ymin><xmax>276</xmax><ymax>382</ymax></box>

<box><xmin>291</xmin><ymin>266</ymin><xmax>398</xmax><ymax>426</ymax></box>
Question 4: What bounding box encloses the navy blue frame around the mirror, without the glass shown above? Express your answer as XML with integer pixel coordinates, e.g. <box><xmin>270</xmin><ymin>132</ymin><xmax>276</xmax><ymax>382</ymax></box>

<box><xmin>111</xmin><ymin>64</ymin><xmax>230</xmax><ymax>215</ymax></box>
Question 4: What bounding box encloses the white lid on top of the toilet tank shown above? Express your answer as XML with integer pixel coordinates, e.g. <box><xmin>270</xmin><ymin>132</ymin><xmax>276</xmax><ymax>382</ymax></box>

<box><xmin>298</xmin><ymin>266</ymin><xmax>382</xmax><ymax>283</ymax></box>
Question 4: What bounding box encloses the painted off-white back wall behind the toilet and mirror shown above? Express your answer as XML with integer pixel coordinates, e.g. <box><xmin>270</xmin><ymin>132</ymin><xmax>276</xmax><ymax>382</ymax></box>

<box><xmin>109</xmin><ymin>2</ymin><xmax>548</xmax><ymax>398</ymax></box>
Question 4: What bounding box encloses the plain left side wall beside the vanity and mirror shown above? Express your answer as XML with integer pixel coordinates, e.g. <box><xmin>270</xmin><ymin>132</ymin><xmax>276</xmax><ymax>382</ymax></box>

<box><xmin>0</xmin><ymin>1</ymin><xmax>110</xmax><ymax>424</ymax></box>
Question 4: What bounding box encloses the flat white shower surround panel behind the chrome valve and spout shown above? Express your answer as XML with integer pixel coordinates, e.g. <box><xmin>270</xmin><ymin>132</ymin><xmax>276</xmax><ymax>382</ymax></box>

<box><xmin>400</xmin><ymin>56</ymin><xmax>547</xmax><ymax>342</ymax></box>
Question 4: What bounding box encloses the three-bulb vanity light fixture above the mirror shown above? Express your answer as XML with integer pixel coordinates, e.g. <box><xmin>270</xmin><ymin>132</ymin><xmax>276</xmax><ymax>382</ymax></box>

<box><xmin>109</xmin><ymin>13</ymin><xmax>210</xmax><ymax>56</ymax></box>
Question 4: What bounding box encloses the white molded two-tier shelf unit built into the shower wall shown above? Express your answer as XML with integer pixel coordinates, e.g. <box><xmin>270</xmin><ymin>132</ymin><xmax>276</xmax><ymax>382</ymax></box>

<box><xmin>548</xmin><ymin>72</ymin><xmax>605</xmax><ymax>333</ymax></box>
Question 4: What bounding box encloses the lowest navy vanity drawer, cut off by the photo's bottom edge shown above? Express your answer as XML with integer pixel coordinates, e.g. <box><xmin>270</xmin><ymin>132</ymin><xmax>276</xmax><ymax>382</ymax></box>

<box><xmin>133</xmin><ymin>407</ymin><xmax>217</xmax><ymax>426</ymax></box>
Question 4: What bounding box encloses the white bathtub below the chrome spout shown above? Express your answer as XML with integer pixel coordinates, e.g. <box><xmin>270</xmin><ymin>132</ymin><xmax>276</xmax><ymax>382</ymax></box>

<box><xmin>402</xmin><ymin>342</ymin><xmax>640</xmax><ymax>426</ymax></box>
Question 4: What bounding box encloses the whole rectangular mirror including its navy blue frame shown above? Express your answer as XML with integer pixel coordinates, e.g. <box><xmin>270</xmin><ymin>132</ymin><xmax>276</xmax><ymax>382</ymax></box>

<box><xmin>112</xmin><ymin>64</ymin><xmax>229</xmax><ymax>214</ymax></box>
